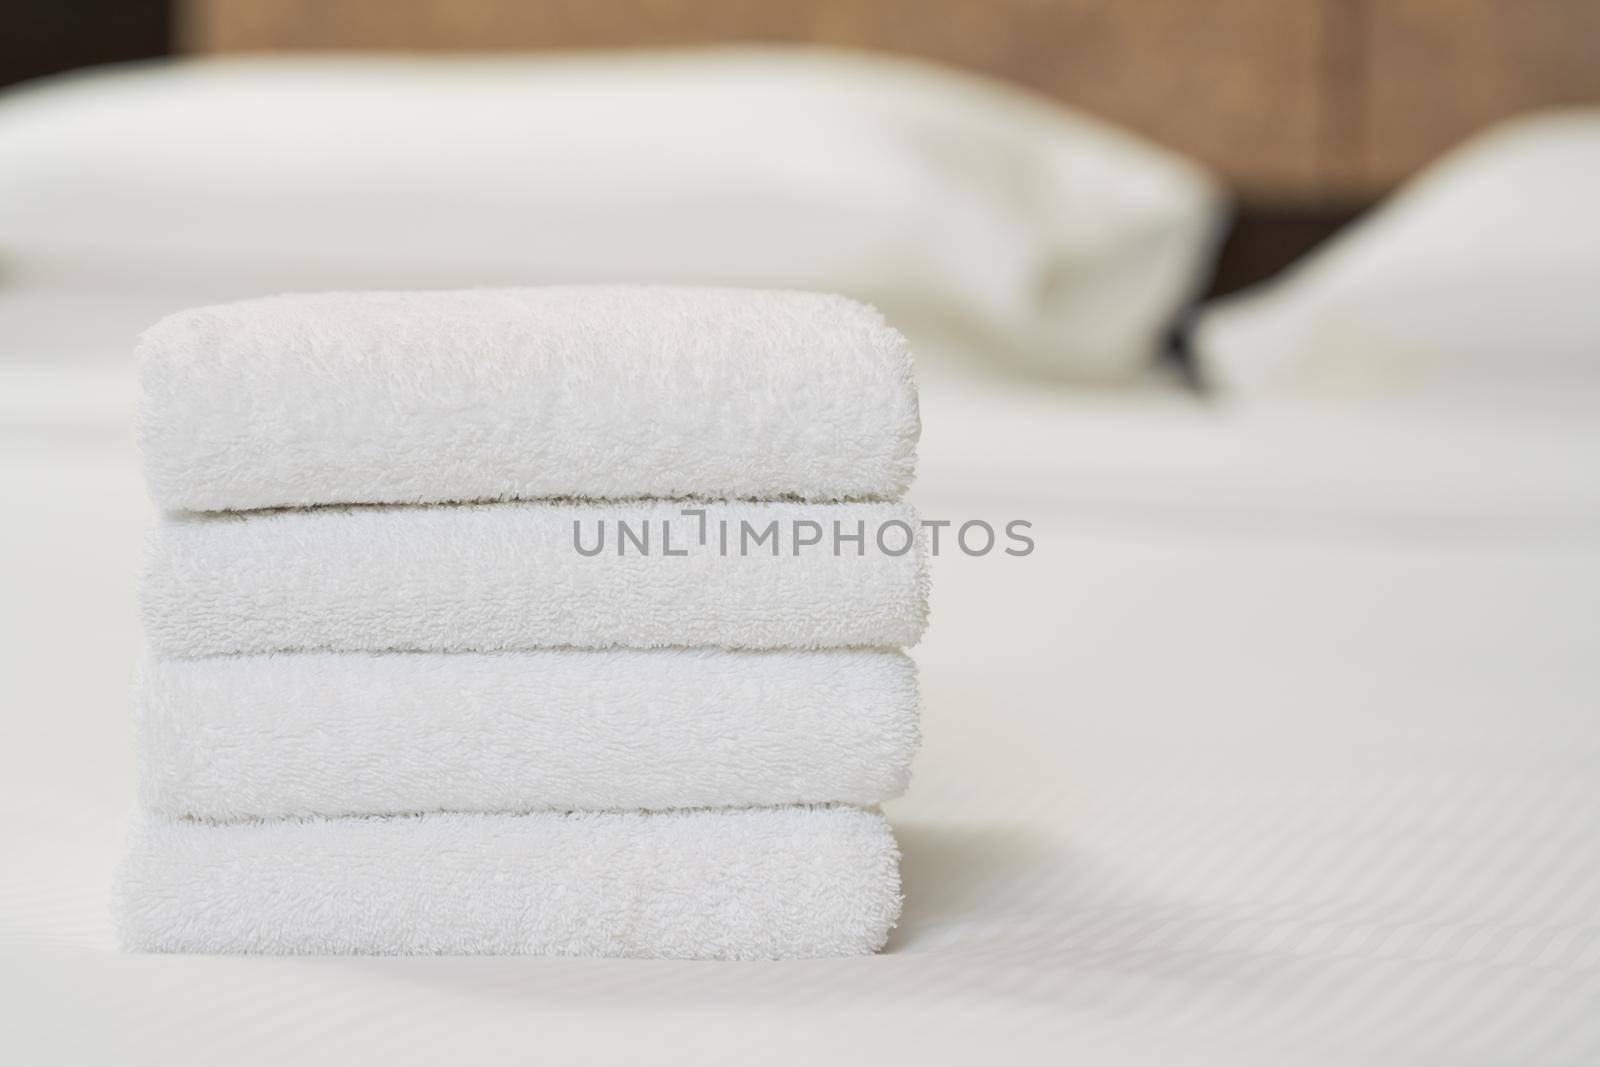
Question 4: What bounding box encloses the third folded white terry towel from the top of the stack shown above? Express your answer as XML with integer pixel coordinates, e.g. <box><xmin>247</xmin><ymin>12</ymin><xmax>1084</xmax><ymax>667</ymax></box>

<box><xmin>134</xmin><ymin>649</ymin><xmax>918</xmax><ymax>819</ymax></box>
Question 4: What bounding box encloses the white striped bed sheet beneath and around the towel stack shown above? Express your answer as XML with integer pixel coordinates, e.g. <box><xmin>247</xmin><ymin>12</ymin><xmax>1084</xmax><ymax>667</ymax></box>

<box><xmin>0</xmin><ymin>301</ymin><xmax>1600</xmax><ymax>1065</ymax></box>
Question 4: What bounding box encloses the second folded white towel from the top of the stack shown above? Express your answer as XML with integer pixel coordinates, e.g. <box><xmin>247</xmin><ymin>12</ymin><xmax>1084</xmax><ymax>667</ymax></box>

<box><xmin>142</xmin><ymin>502</ymin><xmax>928</xmax><ymax>657</ymax></box>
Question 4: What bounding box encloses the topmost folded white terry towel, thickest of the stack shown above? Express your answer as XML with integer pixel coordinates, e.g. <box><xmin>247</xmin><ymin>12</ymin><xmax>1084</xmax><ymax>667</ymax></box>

<box><xmin>139</xmin><ymin>286</ymin><xmax>918</xmax><ymax>510</ymax></box>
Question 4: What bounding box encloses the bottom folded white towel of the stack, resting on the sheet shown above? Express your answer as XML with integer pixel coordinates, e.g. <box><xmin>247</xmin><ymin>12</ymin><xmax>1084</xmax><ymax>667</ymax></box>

<box><xmin>114</xmin><ymin>806</ymin><xmax>901</xmax><ymax>960</ymax></box>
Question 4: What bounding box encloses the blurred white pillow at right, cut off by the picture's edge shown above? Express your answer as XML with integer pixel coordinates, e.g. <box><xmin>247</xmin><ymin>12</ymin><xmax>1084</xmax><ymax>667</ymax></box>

<box><xmin>1195</xmin><ymin>110</ymin><xmax>1600</xmax><ymax>410</ymax></box>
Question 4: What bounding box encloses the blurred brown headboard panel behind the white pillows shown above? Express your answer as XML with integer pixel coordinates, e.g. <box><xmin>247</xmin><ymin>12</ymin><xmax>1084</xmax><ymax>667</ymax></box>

<box><xmin>176</xmin><ymin>0</ymin><xmax>1600</xmax><ymax>203</ymax></box>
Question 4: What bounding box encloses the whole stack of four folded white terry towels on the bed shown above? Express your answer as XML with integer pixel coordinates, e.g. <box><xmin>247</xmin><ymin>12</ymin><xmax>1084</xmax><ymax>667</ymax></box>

<box><xmin>115</xmin><ymin>286</ymin><xmax>926</xmax><ymax>958</ymax></box>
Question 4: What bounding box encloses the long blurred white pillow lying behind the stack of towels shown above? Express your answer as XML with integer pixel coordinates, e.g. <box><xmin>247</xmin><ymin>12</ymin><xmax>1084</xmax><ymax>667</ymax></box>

<box><xmin>0</xmin><ymin>50</ymin><xmax>1219</xmax><ymax>376</ymax></box>
